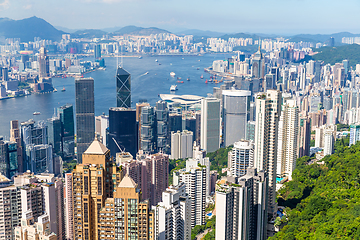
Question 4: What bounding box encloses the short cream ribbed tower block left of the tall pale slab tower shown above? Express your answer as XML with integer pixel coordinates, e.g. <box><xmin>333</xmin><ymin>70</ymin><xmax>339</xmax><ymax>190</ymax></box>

<box><xmin>170</xmin><ymin>130</ymin><xmax>193</xmax><ymax>159</ymax></box>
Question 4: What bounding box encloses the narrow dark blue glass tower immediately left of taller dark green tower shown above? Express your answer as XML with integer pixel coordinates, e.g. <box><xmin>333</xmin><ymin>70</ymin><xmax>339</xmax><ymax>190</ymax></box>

<box><xmin>47</xmin><ymin>117</ymin><xmax>62</xmax><ymax>156</ymax></box>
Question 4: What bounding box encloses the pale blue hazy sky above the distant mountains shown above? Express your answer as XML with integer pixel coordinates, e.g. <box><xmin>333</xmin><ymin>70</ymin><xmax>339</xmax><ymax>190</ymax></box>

<box><xmin>0</xmin><ymin>0</ymin><xmax>360</xmax><ymax>34</ymax></box>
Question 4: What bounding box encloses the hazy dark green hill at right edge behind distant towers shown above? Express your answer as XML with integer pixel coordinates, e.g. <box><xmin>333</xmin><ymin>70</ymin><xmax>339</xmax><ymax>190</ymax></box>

<box><xmin>312</xmin><ymin>44</ymin><xmax>360</xmax><ymax>66</ymax></box>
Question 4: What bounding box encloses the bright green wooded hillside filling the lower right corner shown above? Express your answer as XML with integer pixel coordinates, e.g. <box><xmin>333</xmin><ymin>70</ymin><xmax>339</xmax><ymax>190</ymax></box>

<box><xmin>270</xmin><ymin>136</ymin><xmax>360</xmax><ymax>240</ymax></box>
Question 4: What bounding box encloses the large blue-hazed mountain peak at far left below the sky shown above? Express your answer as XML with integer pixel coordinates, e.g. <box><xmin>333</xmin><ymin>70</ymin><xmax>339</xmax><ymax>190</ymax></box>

<box><xmin>0</xmin><ymin>17</ymin><xmax>65</xmax><ymax>42</ymax></box>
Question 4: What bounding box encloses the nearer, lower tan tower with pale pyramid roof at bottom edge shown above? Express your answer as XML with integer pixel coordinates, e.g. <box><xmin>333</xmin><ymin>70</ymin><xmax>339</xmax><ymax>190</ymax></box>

<box><xmin>97</xmin><ymin>175</ymin><xmax>154</xmax><ymax>240</ymax></box>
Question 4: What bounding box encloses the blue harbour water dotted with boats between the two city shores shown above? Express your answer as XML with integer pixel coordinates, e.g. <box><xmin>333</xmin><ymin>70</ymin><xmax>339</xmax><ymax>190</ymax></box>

<box><xmin>0</xmin><ymin>54</ymin><xmax>231</xmax><ymax>140</ymax></box>
